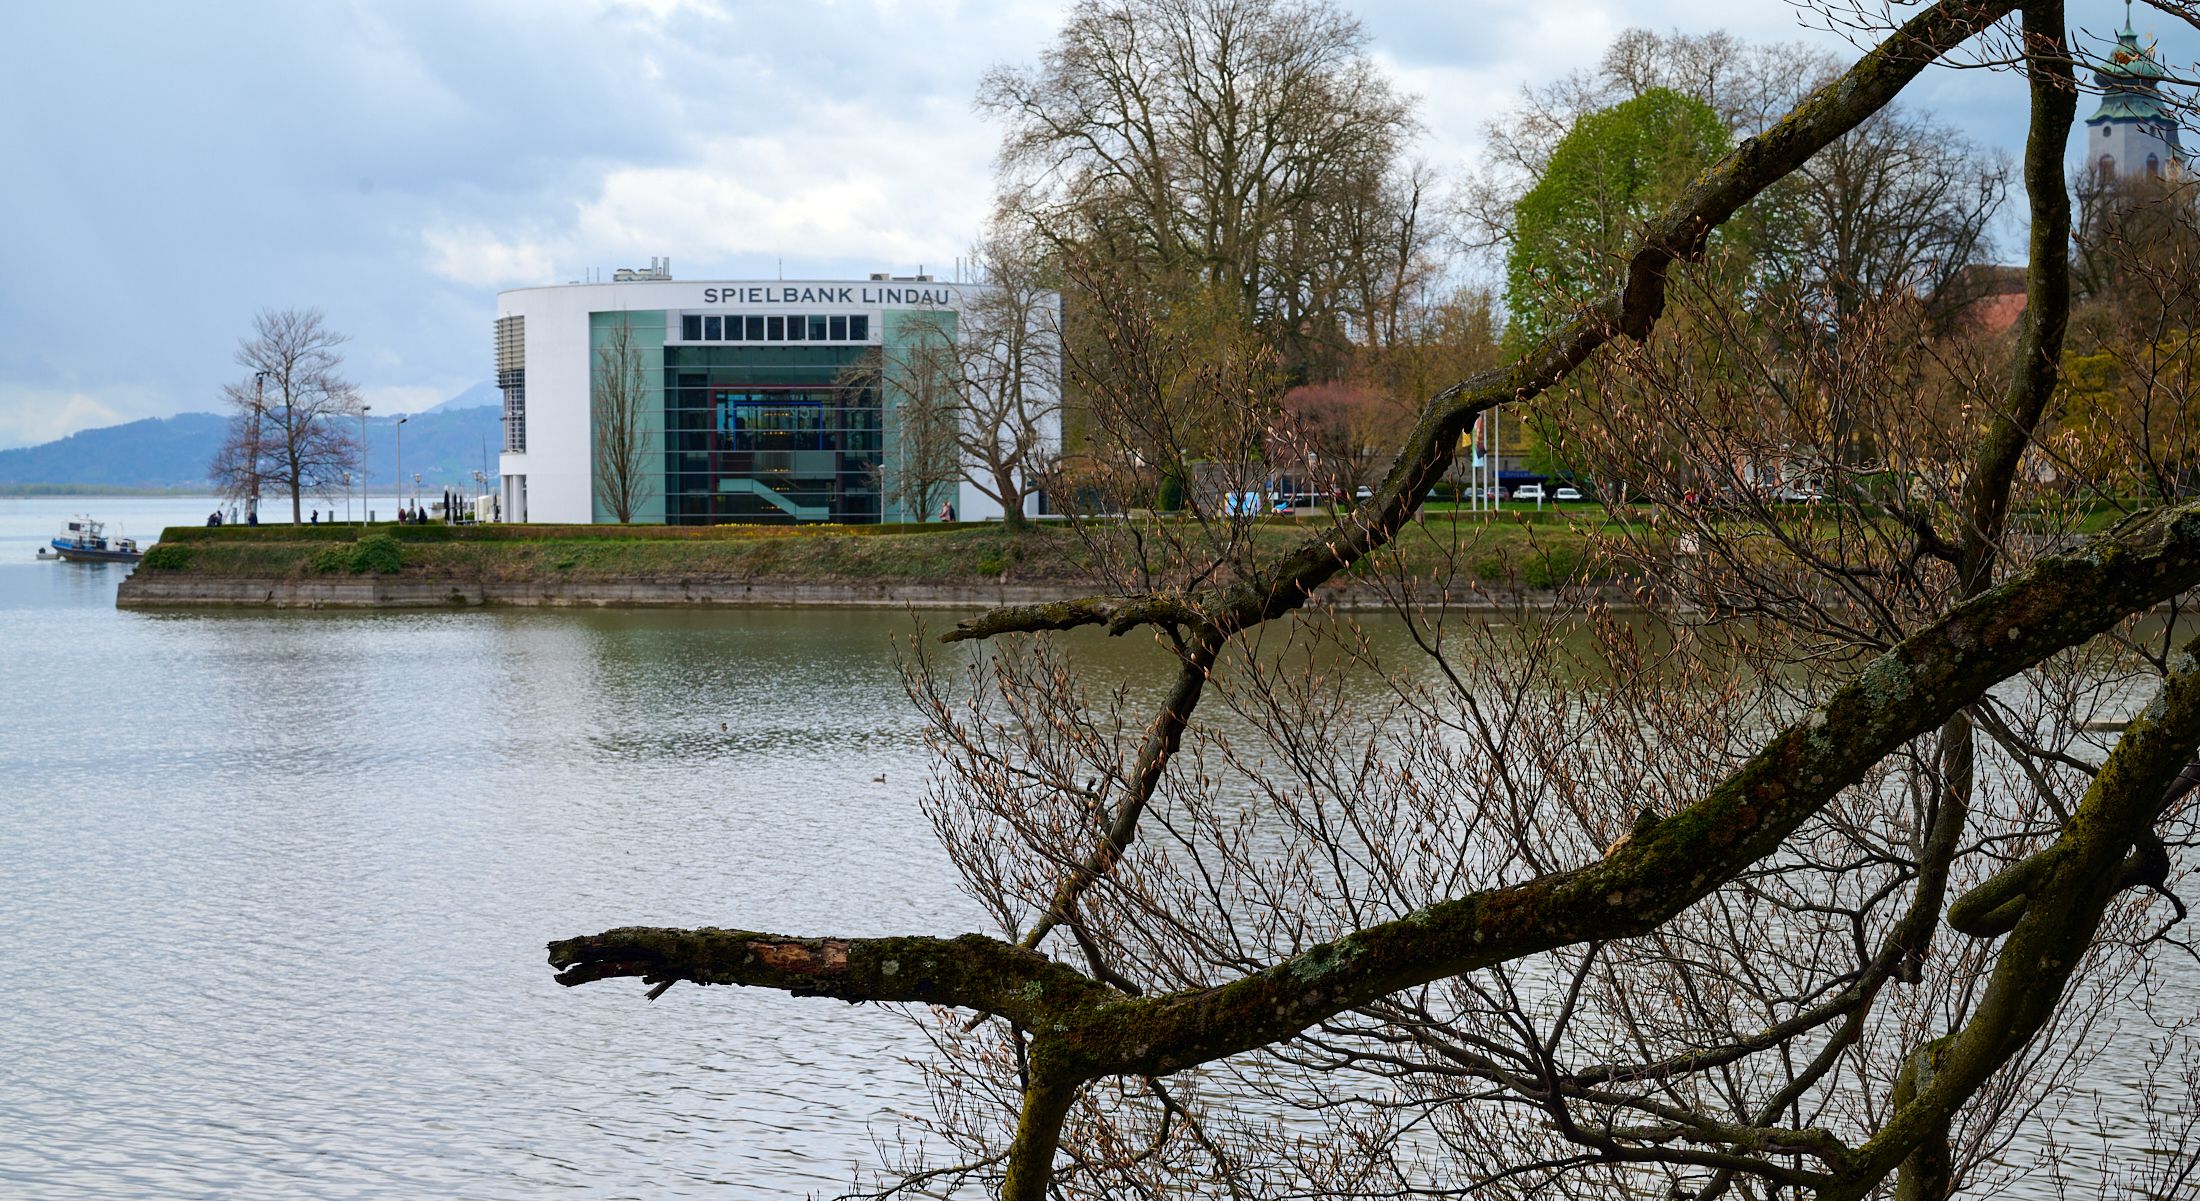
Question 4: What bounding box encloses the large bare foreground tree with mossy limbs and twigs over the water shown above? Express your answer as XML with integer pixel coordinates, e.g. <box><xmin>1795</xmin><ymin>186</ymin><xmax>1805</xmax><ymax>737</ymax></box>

<box><xmin>550</xmin><ymin>9</ymin><xmax>2200</xmax><ymax>1201</ymax></box>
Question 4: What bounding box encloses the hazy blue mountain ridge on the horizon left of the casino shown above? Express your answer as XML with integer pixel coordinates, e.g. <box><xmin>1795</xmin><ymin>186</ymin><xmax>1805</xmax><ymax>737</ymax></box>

<box><xmin>0</xmin><ymin>385</ymin><xmax>504</xmax><ymax>491</ymax></box>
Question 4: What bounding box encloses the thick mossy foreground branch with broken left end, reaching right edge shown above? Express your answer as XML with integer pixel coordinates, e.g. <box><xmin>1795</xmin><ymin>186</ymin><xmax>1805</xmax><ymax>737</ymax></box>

<box><xmin>550</xmin><ymin>502</ymin><xmax>2200</xmax><ymax>1080</ymax></box>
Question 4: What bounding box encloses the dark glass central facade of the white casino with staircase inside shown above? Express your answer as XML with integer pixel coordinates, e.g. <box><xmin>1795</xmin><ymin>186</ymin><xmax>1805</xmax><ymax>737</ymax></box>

<box><xmin>664</xmin><ymin>340</ymin><xmax>884</xmax><ymax>526</ymax></box>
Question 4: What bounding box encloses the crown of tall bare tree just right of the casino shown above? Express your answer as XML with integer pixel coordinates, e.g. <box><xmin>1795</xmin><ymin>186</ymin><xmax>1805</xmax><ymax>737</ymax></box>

<box><xmin>979</xmin><ymin>0</ymin><xmax>1426</xmax><ymax>367</ymax></box>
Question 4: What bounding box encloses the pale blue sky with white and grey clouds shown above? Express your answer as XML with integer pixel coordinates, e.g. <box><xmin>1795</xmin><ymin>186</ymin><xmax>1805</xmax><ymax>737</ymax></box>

<box><xmin>0</xmin><ymin>0</ymin><xmax>2196</xmax><ymax>447</ymax></box>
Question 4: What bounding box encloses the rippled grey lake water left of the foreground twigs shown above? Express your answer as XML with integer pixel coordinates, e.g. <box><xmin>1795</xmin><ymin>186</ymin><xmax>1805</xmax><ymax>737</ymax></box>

<box><xmin>0</xmin><ymin>497</ymin><xmax>2182</xmax><ymax>1199</ymax></box>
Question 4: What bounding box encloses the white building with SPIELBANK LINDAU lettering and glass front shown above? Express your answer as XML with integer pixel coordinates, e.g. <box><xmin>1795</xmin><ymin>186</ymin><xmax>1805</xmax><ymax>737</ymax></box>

<box><xmin>495</xmin><ymin>260</ymin><xmax>1060</xmax><ymax>524</ymax></box>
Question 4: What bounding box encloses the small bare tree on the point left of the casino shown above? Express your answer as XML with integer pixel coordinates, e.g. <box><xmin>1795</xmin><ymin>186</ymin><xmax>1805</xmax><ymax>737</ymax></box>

<box><xmin>209</xmin><ymin>308</ymin><xmax>359</xmax><ymax>521</ymax></box>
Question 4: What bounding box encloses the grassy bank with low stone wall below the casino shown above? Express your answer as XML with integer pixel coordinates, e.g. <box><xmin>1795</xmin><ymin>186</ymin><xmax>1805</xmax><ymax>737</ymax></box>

<box><xmin>114</xmin><ymin>521</ymin><xmax>1617</xmax><ymax>609</ymax></box>
